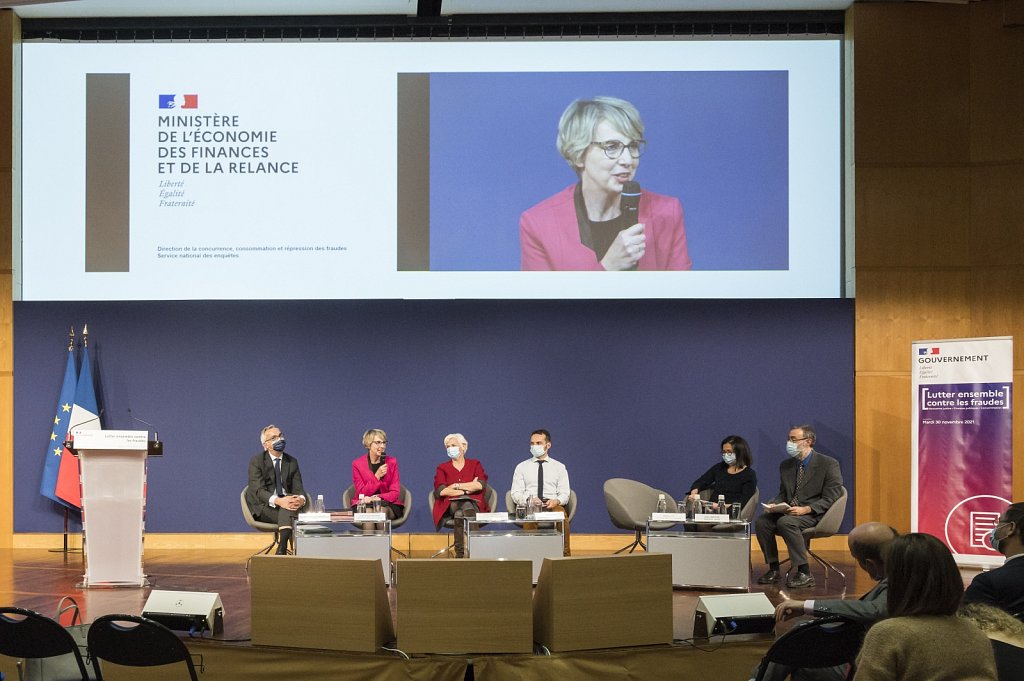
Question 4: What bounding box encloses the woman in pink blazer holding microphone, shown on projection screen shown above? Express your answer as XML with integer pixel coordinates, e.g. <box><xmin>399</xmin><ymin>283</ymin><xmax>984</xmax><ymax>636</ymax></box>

<box><xmin>519</xmin><ymin>97</ymin><xmax>692</xmax><ymax>270</ymax></box>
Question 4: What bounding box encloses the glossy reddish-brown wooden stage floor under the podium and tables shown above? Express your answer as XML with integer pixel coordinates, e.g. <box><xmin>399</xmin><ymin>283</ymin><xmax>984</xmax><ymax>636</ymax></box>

<box><xmin>0</xmin><ymin>549</ymin><xmax>873</xmax><ymax>641</ymax></box>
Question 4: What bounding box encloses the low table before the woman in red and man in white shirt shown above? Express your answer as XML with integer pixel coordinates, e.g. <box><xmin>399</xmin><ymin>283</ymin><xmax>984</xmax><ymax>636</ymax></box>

<box><xmin>464</xmin><ymin>517</ymin><xmax>565</xmax><ymax>584</ymax></box>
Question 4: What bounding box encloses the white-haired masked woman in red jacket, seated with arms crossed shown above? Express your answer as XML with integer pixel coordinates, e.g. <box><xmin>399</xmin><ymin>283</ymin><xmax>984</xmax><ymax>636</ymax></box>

<box><xmin>433</xmin><ymin>433</ymin><xmax>490</xmax><ymax>558</ymax></box>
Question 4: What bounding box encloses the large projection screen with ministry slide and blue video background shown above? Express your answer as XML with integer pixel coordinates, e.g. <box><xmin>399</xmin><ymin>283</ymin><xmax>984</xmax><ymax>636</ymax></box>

<box><xmin>22</xmin><ymin>40</ymin><xmax>842</xmax><ymax>300</ymax></box>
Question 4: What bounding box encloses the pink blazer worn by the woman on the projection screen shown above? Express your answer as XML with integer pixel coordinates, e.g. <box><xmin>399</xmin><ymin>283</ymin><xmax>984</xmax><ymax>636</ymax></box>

<box><xmin>519</xmin><ymin>184</ymin><xmax>693</xmax><ymax>270</ymax></box>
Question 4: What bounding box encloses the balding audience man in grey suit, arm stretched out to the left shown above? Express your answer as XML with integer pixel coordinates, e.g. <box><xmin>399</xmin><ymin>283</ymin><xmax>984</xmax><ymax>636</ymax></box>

<box><xmin>754</xmin><ymin>522</ymin><xmax>899</xmax><ymax>681</ymax></box>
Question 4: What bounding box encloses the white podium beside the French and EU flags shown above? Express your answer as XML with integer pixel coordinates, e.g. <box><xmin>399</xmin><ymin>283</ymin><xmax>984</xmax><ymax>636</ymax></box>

<box><xmin>73</xmin><ymin>430</ymin><xmax>148</xmax><ymax>588</ymax></box>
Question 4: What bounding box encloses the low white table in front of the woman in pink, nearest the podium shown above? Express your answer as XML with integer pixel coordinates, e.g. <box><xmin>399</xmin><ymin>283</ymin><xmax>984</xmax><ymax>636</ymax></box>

<box><xmin>294</xmin><ymin>520</ymin><xmax>391</xmax><ymax>585</ymax></box>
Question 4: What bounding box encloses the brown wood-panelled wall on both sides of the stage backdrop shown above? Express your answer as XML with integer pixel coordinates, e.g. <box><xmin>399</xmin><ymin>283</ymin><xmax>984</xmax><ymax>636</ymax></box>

<box><xmin>0</xmin><ymin>0</ymin><xmax>1024</xmax><ymax>548</ymax></box>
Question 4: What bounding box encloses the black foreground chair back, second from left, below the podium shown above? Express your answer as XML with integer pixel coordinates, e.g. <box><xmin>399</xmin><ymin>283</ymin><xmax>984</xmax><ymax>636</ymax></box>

<box><xmin>89</xmin><ymin>614</ymin><xmax>199</xmax><ymax>681</ymax></box>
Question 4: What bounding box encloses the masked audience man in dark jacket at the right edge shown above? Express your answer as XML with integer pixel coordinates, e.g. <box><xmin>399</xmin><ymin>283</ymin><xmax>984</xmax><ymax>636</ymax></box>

<box><xmin>964</xmin><ymin>502</ymin><xmax>1024</xmax><ymax>621</ymax></box>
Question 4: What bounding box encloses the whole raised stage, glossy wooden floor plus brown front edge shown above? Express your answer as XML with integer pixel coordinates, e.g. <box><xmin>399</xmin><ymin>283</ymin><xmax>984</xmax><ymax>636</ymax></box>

<box><xmin>0</xmin><ymin>549</ymin><xmax>872</xmax><ymax>681</ymax></box>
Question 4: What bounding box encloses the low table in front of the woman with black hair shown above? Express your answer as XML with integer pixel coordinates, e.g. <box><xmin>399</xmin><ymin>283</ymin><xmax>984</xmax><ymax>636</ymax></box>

<box><xmin>647</xmin><ymin>520</ymin><xmax>751</xmax><ymax>591</ymax></box>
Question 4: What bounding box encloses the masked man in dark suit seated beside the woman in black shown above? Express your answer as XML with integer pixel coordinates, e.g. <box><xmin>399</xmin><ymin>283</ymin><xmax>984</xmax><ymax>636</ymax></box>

<box><xmin>754</xmin><ymin>425</ymin><xmax>843</xmax><ymax>589</ymax></box>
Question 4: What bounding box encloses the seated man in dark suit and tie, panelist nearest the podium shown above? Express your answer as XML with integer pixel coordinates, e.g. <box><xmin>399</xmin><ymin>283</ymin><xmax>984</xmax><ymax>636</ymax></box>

<box><xmin>246</xmin><ymin>424</ymin><xmax>306</xmax><ymax>555</ymax></box>
